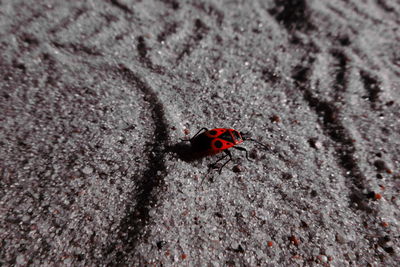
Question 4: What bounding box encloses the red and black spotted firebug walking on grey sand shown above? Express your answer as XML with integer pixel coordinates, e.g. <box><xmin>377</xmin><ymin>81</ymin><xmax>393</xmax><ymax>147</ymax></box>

<box><xmin>182</xmin><ymin>128</ymin><xmax>268</xmax><ymax>173</ymax></box>
